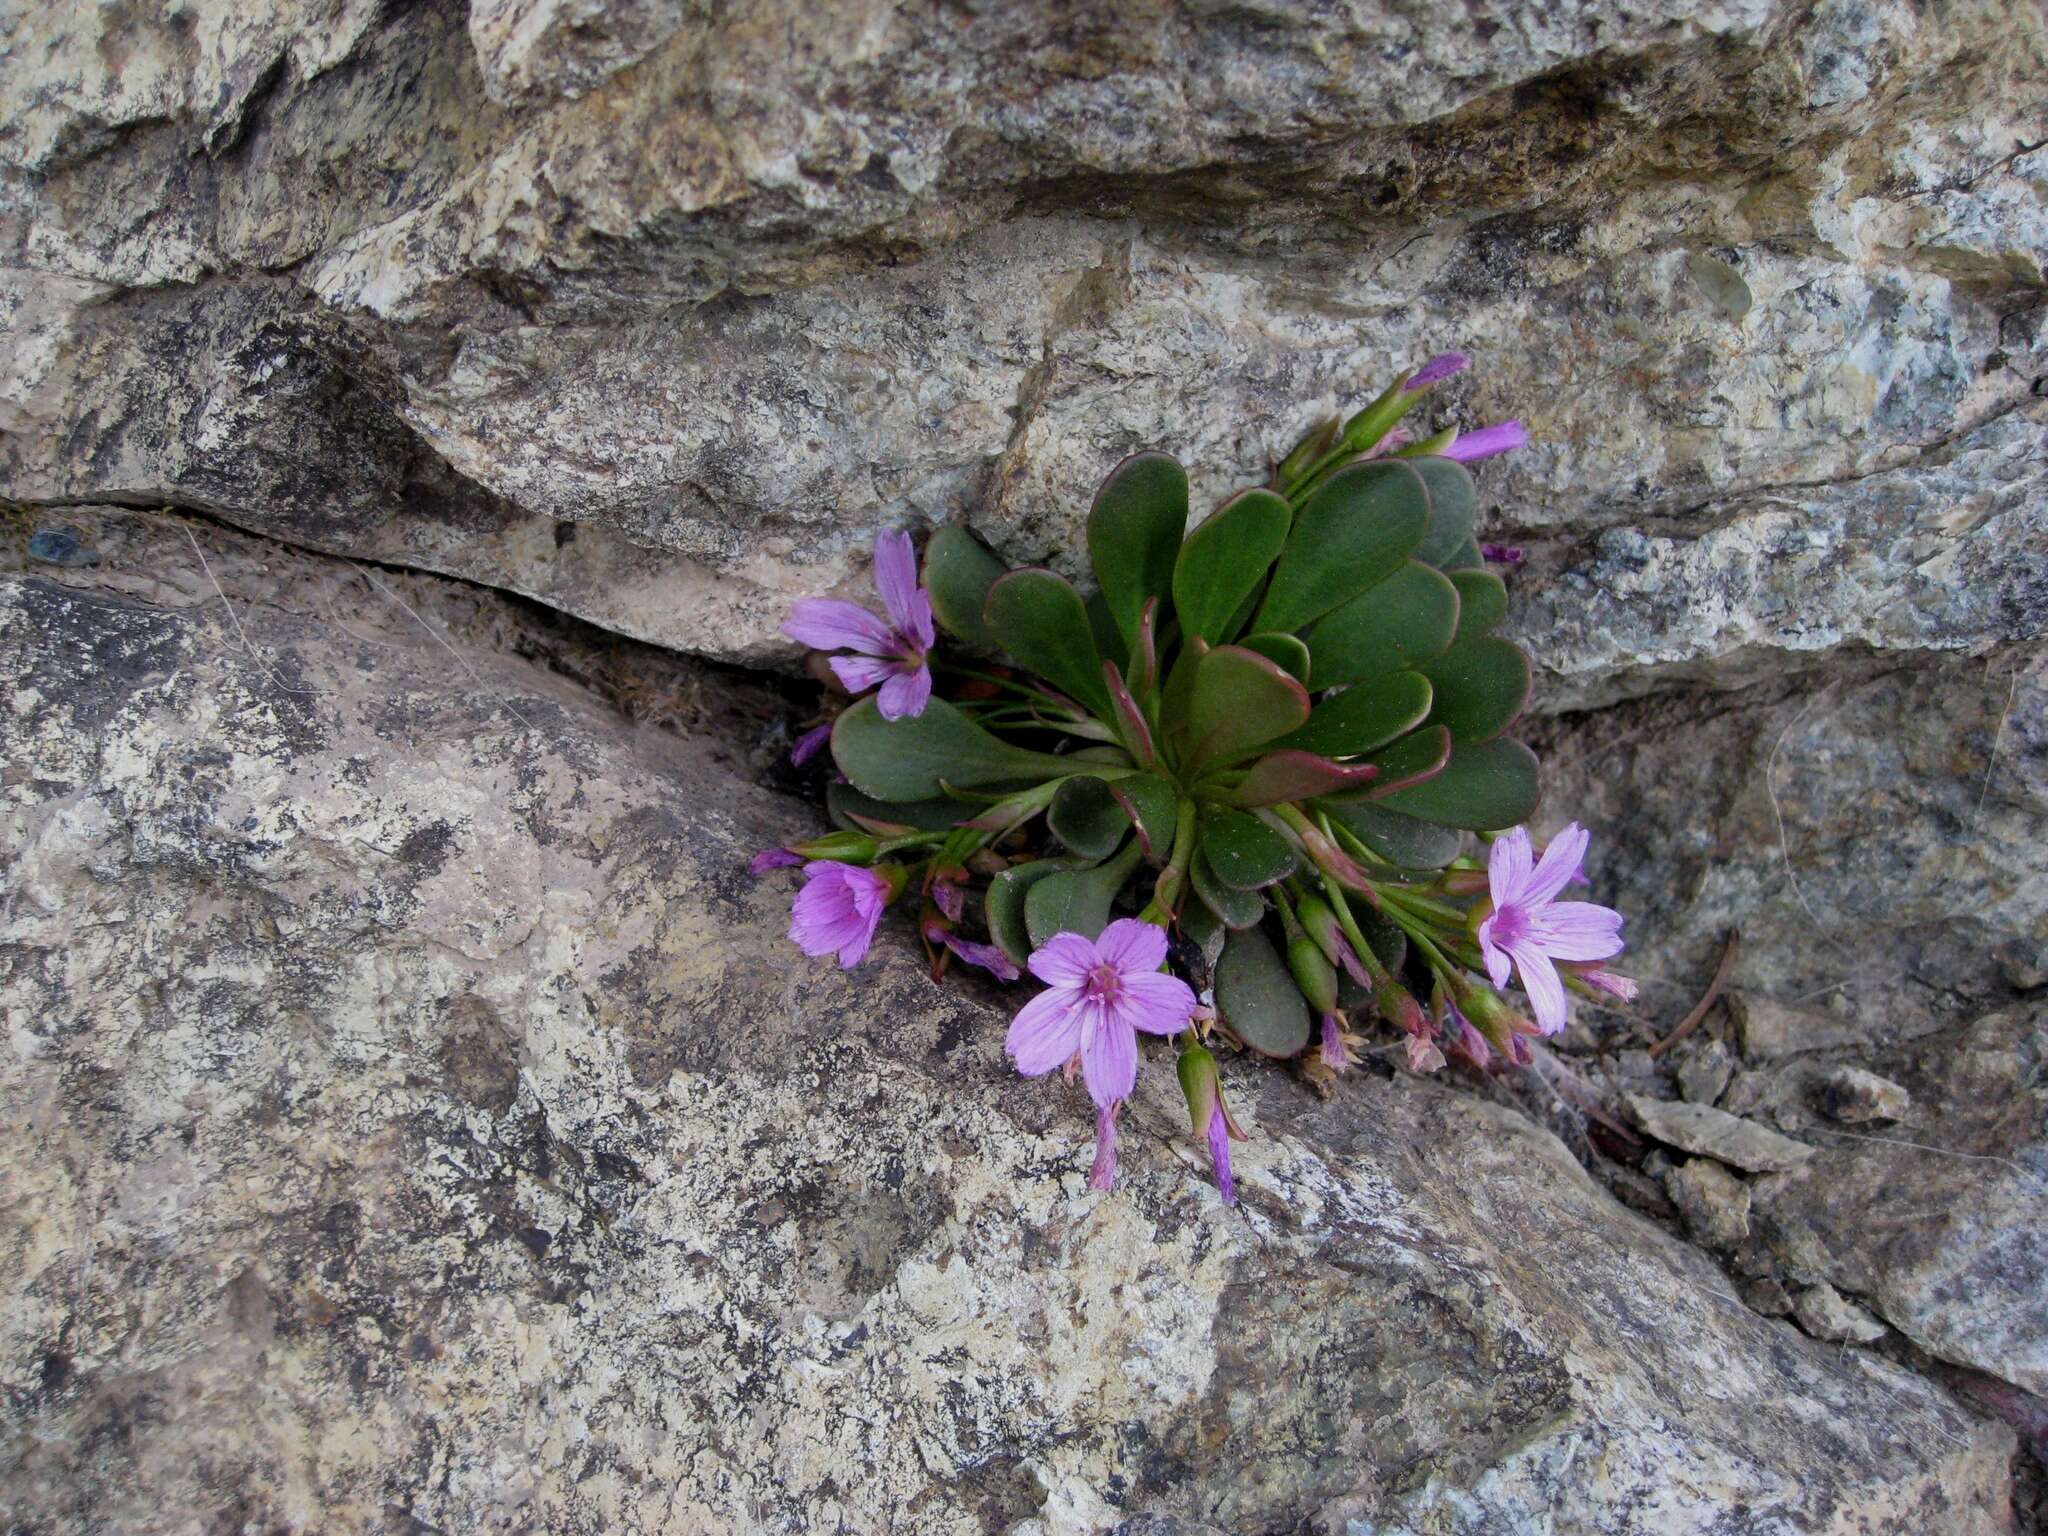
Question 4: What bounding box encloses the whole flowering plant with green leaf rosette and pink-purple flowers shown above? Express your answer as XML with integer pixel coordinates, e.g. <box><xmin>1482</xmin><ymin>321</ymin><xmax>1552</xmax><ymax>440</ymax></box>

<box><xmin>754</xmin><ymin>352</ymin><xmax>1634</xmax><ymax>1202</ymax></box>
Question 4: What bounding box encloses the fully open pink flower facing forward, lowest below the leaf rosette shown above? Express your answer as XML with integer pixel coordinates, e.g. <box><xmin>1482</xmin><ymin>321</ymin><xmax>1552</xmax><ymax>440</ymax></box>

<box><xmin>1004</xmin><ymin>918</ymin><xmax>1194</xmax><ymax>1108</ymax></box>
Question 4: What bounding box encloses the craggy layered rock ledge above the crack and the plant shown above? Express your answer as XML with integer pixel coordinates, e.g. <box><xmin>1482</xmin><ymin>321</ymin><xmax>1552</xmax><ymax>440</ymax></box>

<box><xmin>0</xmin><ymin>0</ymin><xmax>2048</xmax><ymax>684</ymax></box>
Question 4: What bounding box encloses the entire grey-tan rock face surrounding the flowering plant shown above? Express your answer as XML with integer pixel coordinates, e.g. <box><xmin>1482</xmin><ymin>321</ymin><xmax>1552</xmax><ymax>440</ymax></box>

<box><xmin>0</xmin><ymin>0</ymin><xmax>2048</xmax><ymax>1536</ymax></box>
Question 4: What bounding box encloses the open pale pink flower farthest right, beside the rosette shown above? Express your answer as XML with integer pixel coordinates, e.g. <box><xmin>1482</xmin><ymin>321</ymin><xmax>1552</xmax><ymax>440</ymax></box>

<box><xmin>1479</xmin><ymin>821</ymin><xmax>1622</xmax><ymax>1034</ymax></box>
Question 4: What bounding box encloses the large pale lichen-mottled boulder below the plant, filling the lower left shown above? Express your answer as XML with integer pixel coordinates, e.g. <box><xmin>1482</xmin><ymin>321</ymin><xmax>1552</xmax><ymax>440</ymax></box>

<box><xmin>0</xmin><ymin>512</ymin><xmax>2013</xmax><ymax>1536</ymax></box>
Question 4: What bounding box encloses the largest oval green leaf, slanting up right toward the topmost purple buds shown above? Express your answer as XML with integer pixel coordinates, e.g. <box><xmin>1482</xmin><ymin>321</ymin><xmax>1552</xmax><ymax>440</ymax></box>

<box><xmin>1251</xmin><ymin>459</ymin><xmax>1430</xmax><ymax>634</ymax></box>
